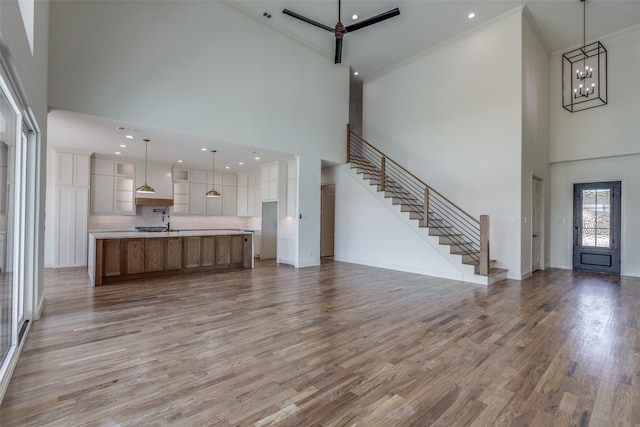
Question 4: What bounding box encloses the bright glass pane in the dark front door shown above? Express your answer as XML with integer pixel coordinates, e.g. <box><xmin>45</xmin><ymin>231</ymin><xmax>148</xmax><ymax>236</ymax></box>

<box><xmin>581</xmin><ymin>188</ymin><xmax>611</xmax><ymax>248</ymax></box>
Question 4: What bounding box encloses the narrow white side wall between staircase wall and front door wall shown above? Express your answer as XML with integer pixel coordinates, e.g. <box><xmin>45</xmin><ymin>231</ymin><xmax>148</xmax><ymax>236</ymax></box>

<box><xmin>520</xmin><ymin>12</ymin><xmax>550</xmax><ymax>277</ymax></box>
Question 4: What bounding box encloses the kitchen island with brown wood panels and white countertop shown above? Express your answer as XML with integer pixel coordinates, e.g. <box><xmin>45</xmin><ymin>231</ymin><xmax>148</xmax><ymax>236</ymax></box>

<box><xmin>88</xmin><ymin>230</ymin><xmax>253</xmax><ymax>286</ymax></box>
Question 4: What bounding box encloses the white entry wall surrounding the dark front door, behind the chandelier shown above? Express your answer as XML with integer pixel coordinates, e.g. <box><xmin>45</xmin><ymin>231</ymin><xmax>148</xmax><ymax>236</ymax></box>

<box><xmin>549</xmin><ymin>27</ymin><xmax>640</xmax><ymax>276</ymax></box>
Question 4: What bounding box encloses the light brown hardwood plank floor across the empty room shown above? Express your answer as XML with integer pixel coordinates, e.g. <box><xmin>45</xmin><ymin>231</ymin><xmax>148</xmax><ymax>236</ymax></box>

<box><xmin>0</xmin><ymin>262</ymin><xmax>640</xmax><ymax>427</ymax></box>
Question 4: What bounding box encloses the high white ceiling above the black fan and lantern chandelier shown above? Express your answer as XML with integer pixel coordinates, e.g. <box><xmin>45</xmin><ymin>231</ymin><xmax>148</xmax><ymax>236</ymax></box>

<box><xmin>239</xmin><ymin>0</ymin><xmax>640</xmax><ymax>80</ymax></box>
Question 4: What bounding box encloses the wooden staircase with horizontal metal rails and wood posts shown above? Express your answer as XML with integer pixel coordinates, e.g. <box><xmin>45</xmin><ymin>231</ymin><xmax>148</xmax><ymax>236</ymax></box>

<box><xmin>347</xmin><ymin>129</ymin><xmax>507</xmax><ymax>285</ymax></box>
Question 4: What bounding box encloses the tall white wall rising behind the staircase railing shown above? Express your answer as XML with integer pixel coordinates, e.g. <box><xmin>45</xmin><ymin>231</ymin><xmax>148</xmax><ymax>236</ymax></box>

<box><xmin>364</xmin><ymin>9</ymin><xmax>523</xmax><ymax>278</ymax></box>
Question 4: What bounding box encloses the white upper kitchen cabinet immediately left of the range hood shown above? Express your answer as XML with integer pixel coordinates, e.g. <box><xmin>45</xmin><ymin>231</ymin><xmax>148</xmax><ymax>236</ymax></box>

<box><xmin>90</xmin><ymin>156</ymin><xmax>136</xmax><ymax>215</ymax></box>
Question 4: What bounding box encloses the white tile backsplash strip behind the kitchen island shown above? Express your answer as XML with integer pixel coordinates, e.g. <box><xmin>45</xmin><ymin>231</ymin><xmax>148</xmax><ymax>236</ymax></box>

<box><xmin>89</xmin><ymin>206</ymin><xmax>261</xmax><ymax>231</ymax></box>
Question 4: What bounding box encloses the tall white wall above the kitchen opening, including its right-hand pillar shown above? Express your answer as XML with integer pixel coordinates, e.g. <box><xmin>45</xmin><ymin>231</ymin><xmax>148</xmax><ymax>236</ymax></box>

<box><xmin>49</xmin><ymin>1</ymin><xmax>349</xmax><ymax>265</ymax></box>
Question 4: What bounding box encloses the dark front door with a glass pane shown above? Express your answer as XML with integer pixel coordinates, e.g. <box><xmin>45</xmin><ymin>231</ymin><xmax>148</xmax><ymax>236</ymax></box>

<box><xmin>573</xmin><ymin>181</ymin><xmax>621</xmax><ymax>274</ymax></box>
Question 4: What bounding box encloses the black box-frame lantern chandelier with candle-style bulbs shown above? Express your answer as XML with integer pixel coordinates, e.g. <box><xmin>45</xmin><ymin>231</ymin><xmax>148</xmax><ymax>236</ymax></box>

<box><xmin>562</xmin><ymin>0</ymin><xmax>607</xmax><ymax>113</ymax></box>
